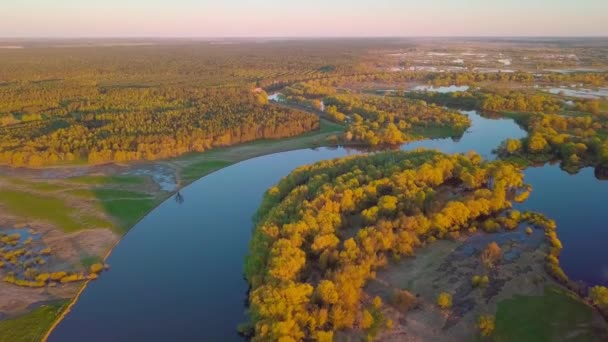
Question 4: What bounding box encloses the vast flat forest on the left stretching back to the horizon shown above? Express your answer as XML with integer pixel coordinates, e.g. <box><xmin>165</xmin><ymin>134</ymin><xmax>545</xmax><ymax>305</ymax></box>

<box><xmin>0</xmin><ymin>41</ymin><xmax>376</xmax><ymax>167</ymax></box>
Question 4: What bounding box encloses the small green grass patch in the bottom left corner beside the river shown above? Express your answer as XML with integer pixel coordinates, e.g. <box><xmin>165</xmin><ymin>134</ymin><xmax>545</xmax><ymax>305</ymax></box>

<box><xmin>0</xmin><ymin>302</ymin><xmax>66</xmax><ymax>342</ymax></box>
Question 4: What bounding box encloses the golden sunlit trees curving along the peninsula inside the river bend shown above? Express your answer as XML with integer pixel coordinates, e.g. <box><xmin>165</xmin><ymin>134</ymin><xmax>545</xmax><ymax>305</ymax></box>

<box><xmin>243</xmin><ymin>151</ymin><xmax>529</xmax><ymax>341</ymax></box>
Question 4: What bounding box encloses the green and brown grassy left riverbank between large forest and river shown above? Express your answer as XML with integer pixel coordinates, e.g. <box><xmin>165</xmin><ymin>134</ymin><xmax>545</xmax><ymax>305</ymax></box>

<box><xmin>0</xmin><ymin>120</ymin><xmax>343</xmax><ymax>339</ymax></box>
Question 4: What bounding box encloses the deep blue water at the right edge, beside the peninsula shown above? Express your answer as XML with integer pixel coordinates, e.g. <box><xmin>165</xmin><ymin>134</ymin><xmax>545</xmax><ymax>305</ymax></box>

<box><xmin>518</xmin><ymin>165</ymin><xmax>608</xmax><ymax>286</ymax></box>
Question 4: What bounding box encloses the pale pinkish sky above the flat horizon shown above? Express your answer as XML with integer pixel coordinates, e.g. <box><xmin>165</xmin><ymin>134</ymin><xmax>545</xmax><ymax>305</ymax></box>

<box><xmin>0</xmin><ymin>0</ymin><xmax>608</xmax><ymax>37</ymax></box>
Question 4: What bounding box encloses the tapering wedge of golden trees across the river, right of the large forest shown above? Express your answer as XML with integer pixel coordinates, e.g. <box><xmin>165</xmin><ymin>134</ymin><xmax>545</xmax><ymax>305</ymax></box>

<box><xmin>281</xmin><ymin>82</ymin><xmax>470</xmax><ymax>147</ymax></box>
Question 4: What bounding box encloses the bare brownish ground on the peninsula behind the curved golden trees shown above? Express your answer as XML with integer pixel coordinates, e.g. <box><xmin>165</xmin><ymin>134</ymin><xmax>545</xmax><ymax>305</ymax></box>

<box><xmin>366</xmin><ymin>229</ymin><xmax>555</xmax><ymax>341</ymax></box>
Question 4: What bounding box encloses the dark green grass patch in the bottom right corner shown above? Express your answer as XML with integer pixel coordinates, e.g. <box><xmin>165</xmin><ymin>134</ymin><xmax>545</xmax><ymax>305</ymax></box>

<box><xmin>492</xmin><ymin>286</ymin><xmax>608</xmax><ymax>342</ymax></box>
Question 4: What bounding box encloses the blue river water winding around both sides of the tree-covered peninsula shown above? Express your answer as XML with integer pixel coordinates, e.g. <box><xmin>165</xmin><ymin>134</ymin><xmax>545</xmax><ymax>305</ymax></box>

<box><xmin>49</xmin><ymin>112</ymin><xmax>608</xmax><ymax>342</ymax></box>
